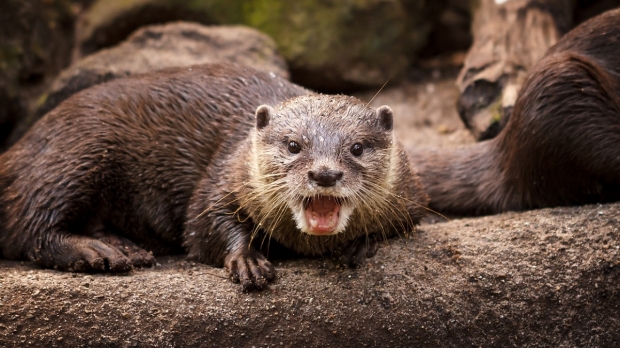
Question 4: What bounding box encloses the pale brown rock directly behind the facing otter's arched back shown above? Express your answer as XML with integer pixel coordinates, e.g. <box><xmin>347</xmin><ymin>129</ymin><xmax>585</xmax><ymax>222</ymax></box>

<box><xmin>14</xmin><ymin>22</ymin><xmax>289</xmax><ymax>142</ymax></box>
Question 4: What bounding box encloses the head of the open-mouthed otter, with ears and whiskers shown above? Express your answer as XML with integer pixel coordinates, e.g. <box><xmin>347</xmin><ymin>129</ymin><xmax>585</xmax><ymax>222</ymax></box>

<box><xmin>251</xmin><ymin>95</ymin><xmax>394</xmax><ymax>235</ymax></box>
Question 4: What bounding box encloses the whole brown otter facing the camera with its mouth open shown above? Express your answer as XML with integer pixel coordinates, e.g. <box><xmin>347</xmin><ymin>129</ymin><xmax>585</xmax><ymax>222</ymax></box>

<box><xmin>0</xmin><ymin>64</ymin><xmax>428</xmax><ymax>290</ymax></box>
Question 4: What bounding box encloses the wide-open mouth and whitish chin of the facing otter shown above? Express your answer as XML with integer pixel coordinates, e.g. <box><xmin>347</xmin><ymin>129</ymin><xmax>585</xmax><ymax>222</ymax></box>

<box><xmin>294</xmin><ymin>196</ymin><xmax>352</xmax><ymax>236</ymax></box>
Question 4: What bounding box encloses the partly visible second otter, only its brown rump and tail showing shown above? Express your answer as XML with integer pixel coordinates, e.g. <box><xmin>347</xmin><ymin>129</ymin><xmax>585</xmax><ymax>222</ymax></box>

<box><xmin>409</xmin><ymin>10</ymin><xmax>620</xmax><ymax>215</ymax></box>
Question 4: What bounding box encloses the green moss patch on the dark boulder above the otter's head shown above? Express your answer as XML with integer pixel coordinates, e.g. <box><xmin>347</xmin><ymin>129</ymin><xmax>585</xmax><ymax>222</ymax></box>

<box><xmin>244</xmin><ymin>0</ymin><xmax>407</xmax><ymax>66</ymax></box>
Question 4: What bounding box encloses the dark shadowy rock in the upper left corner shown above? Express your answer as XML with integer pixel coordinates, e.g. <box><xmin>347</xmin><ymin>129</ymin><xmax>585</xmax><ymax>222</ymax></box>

<box><xmin>0</xmin><ymin>0</ymin><xmax>76</xmax><ymax>149</ymax></box>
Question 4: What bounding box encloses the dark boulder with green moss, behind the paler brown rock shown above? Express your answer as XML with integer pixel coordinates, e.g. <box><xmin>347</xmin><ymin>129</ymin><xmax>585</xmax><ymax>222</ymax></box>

<box><xmin>79</xmin><ymin>0</ymin><xmax>431</xmax><ymax>92</ymax></box>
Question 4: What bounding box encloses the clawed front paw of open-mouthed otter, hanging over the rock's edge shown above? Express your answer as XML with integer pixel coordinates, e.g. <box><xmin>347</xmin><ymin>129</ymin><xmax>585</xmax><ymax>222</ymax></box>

<box><xmin>224</xmin><ymin>248</ymin><xmax>276</xmax><ymax>291</ymax></box>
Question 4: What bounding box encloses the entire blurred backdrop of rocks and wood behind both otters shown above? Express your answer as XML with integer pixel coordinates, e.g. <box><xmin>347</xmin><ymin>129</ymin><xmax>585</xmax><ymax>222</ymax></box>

<box><xmin>0</xmin><ymin>0</ymin><xmax>620</xmax><ymax>150</ymax></box>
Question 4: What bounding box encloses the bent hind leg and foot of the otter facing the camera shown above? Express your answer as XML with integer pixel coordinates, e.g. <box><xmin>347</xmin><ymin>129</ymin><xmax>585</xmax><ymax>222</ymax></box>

<box><xmin>0</xmin><ymin>160</ymin><xmax>140</xmax><ymax>272</ymax></box>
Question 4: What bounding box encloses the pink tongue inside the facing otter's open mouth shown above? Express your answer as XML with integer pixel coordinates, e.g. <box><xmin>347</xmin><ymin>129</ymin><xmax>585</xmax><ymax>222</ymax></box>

<box><xmin>306</xmin><ymin>196</ymin><xmax>340</xmax><ymax>234</ymax></box>
